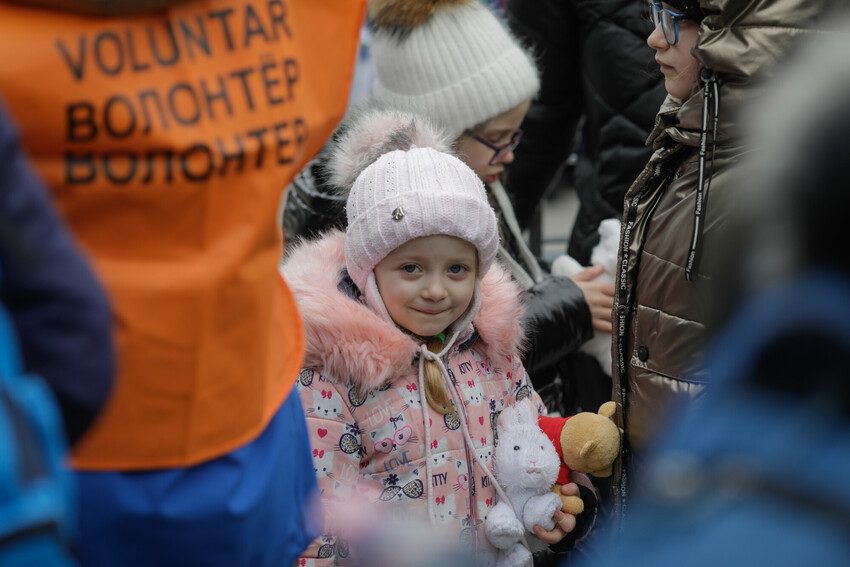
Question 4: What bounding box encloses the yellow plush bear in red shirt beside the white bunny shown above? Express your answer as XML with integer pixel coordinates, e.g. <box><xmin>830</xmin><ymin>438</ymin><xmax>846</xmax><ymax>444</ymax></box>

<box><xmin>537</xmin><ymin>402</ymin><xmax>621</xmax><ymax>514</ymax></box>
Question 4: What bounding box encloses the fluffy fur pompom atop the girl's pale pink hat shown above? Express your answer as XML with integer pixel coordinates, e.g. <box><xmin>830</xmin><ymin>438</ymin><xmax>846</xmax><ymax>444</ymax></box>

<box><xmin>328</xmin><ymin>106</ymin><xmax>451</xmax><ymax>191</ymax></box>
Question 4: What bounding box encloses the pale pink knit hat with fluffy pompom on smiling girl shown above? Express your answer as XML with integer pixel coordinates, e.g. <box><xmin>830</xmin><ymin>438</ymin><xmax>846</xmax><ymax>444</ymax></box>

<box><xmin>329</xmin><ymin>105</ymin><xmax>499</xmax><ymax>322</ymax></box>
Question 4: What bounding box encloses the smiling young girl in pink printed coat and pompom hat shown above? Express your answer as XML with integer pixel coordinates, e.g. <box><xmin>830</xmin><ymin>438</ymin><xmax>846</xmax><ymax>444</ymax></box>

<box><xmin>283</xmin><ymin>111</ymin><xmax>575</xmax><ymax>565</ymax></box>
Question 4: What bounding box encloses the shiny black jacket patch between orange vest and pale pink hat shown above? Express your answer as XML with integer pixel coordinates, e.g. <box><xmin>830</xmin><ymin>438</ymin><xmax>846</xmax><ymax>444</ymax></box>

<box><xmin>283</xmin><ymin>156</ymin><xmax>345</xmax><ymax>246</ymax></box>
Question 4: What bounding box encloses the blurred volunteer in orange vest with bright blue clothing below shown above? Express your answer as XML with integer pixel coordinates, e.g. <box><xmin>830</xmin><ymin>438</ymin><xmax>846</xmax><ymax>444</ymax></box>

<box><xmin>0</xmin><ymin>0</ymin><xmax>365</xmax><ymax>566</ymax></box>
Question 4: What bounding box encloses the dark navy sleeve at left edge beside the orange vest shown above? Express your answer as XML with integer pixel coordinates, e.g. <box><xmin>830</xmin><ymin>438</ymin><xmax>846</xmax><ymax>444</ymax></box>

<box><xmin>0</xmin><ymin>105</ymin><xmax>115</xmax><ymax>443</ymax></box>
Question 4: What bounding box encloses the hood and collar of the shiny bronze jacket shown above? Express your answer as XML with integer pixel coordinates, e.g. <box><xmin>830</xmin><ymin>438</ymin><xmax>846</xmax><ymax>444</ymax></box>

<box><xmin>648</xmin><ymin>0</ymin><xmax>844</xmax><ymax>148</ymax></box>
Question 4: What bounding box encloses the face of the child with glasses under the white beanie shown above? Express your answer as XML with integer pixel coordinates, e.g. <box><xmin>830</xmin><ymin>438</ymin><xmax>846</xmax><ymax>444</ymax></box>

<box><xmin>457</xmin><ymin>101</ymin><xmax>531</xmax><ymax>183</ymax></box>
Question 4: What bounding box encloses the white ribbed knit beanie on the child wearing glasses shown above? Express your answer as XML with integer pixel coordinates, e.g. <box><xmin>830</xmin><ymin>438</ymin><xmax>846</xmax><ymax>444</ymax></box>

<box><xmin>372</xmin><ymin>0</ymin><xmax>540</xmax><ymax>139</ymax></box>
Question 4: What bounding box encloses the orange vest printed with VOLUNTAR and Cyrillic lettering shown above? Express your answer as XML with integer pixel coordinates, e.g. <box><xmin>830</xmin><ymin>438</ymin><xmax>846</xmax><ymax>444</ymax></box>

<box><xmin>0</xmin><ymin>0</ymin><xmax>365</xmax><ymax>470</ymax></box>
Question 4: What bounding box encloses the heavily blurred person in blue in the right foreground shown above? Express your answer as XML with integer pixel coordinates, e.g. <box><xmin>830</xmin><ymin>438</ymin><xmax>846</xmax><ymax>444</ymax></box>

<box><xmin>587</xmin><ymin>20</ymin><xmax>850</xmax><ymax>567</ymax></box>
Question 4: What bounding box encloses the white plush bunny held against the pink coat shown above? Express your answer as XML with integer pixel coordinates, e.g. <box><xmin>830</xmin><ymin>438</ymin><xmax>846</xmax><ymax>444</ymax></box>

<box><xmin>484</xmin><ymin>398</ymin><xmax>561</xmax><ymax>567</ymax></box>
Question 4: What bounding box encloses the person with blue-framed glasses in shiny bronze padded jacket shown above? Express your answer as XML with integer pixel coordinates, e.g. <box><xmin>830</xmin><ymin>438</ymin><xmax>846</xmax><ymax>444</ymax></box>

<box><xmin>612</xmin><ymin>0</ymin><xmax>840</xmax><ymax>520</ymax></box>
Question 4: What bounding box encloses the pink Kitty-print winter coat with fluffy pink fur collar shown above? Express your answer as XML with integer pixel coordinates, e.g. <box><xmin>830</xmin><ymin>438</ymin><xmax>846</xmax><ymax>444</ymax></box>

<box><xmin>283</xmin><ymin>232</ymin><xmax>544</xmax><ymax>566</ymax></box>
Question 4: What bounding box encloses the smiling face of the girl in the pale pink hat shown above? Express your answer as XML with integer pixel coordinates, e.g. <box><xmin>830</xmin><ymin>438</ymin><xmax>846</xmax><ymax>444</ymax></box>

<box><xmin>375</xmin><ymin>234</ymin><xmax>478</xmax><ymax>337</ymax></box>
